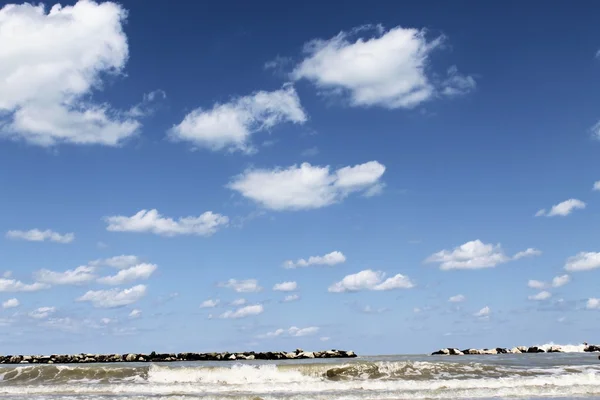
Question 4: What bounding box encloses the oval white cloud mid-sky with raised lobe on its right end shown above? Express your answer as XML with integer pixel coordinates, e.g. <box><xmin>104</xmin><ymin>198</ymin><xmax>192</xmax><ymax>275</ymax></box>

<box><xmin>227</xmin><ymin>161</ymin><xmax>385</xmax><ymax>211</ymax></box>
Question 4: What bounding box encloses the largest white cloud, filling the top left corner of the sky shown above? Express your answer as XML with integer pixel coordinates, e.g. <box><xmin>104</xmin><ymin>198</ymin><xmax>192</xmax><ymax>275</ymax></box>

<box><xmin>0</xmin><ymin>1</ymin><xmax>141</xmax><ymax>146</ymax></box>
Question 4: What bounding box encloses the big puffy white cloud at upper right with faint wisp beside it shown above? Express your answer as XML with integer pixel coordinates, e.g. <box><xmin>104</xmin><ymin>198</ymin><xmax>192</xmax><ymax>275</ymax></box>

<box><xmin>292</xmin><ymin>25</ymin><xmax>475</xmax><ymax>109</ymax></box>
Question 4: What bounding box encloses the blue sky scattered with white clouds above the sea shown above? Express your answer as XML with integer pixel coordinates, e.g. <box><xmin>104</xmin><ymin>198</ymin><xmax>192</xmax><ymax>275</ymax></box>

<box><xmin>0</xmin><ymin>0</ymin><xmax>600</xmax><ymax>354</ymax></box>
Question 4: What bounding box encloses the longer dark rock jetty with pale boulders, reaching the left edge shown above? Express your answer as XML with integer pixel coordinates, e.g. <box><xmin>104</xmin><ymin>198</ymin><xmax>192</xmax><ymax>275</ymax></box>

<box><xmin>0</xmin><ymin>349</ymin><xmax>356</xmax><ymax>364</ymax></box>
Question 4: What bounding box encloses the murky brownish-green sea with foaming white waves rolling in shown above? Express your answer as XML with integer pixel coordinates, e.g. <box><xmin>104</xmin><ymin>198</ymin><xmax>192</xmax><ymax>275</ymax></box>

<box><xmin>0</xmin><ymin>346</ymin><xmax>600</xmax><ymax>400</ymax></box>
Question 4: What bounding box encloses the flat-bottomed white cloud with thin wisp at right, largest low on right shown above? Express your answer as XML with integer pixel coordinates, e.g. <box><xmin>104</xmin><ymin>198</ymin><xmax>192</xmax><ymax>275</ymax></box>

<box><xmin>425</xmin><ymin>239</ymin><xmax>541</xmax><ymax>270</ymax></box>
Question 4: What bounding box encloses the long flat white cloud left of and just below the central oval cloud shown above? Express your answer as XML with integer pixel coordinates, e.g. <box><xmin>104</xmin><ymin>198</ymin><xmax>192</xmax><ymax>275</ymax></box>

<box><xmin>105</xmin><ymin>209</ymin><xmax>229</xmax><ymax>236</ymax></box>
